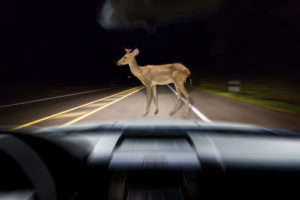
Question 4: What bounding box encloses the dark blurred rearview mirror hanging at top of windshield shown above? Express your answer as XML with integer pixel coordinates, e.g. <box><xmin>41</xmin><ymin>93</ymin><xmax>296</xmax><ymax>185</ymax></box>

<box><xmin>97</xmin><ymin>0</ymin><xmax>223</xmax><ymax>32</ymax></box>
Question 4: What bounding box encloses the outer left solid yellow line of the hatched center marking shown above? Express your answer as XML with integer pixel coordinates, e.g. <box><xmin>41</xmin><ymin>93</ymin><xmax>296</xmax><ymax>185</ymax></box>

<box><xmin>11</xmin><ymin>86</ymin><xmax>143</xmax><ymax>130</ymax></box>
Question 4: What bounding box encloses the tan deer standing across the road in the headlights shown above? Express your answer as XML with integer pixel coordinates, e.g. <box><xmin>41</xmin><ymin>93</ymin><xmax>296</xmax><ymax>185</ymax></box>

<box><xmin>116</xmin><ymin>49</ymin><xmax>191</xmax><ymax>116</ymax></box>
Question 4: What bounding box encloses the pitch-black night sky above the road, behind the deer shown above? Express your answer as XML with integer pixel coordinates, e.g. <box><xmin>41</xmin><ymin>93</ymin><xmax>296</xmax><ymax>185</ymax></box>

<box><xmin>0</xmin><ymin>0</ymin><xmax>300</xmax><ymax>85</ymax></box>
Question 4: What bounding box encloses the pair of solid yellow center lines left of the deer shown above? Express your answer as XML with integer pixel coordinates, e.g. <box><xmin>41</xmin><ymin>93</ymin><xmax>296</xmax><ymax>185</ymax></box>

<box><xmin>12</xmin><ymin>86</ymin><xmax>144</xmax><ymax>130</ymax></box>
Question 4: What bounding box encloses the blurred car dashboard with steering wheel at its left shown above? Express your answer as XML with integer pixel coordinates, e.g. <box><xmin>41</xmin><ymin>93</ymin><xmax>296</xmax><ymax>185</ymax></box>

<box><xmin>0</xmin><ymin>121</ymin><xmax>300</xmax><ymax>200</ymax></box>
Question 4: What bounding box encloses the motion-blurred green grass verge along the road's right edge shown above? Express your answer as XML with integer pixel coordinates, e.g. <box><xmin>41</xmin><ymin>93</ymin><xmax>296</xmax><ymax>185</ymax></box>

<box><xmin>191</xmin><ymin>78</ymin><xmax>300</xmax><ymax>116</ymax></box>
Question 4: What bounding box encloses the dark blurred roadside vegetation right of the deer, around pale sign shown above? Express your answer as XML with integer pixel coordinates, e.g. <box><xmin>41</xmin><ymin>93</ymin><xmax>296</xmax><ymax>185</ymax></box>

<box><xmin>191</xmin><ymin>77</ymin><xmax>300</xmax><ymax>116</ymax></box>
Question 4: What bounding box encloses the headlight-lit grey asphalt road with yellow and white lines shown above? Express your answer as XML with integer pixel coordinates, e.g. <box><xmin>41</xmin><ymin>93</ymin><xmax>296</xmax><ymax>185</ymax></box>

<box><xmin>0</xmin><ymin>86</ymin><xmax>300</xmax><ymax>131</ymax></box>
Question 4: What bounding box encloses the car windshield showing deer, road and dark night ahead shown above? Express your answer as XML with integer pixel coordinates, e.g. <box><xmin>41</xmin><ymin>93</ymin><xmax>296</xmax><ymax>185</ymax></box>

<box><xmin>0</xmin><ymin>0</ymin><xmax>300</xmax><ymax>131</ymax></box>
